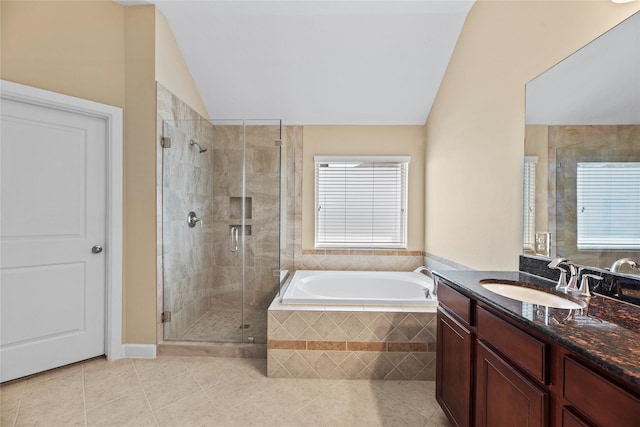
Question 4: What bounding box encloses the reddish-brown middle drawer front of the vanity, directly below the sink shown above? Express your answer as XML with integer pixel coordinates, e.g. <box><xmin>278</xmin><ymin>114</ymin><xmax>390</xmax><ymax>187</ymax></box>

<box><xmin>478</xmin><ymin>307</ymin><xmax>549</xmax><ymax>384</ymax></box>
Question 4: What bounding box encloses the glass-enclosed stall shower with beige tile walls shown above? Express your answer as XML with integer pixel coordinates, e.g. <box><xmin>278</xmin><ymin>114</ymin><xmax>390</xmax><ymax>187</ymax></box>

<box><xmin>159</xmin><ymin>114</ymin><xmax>286</xmax><ymax>344</ymax></box>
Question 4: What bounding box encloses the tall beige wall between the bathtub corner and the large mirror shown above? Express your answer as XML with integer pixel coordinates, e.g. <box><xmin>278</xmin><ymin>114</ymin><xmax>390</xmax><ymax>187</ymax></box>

<box><xmin>425</xmin><ymin>1</ymin><xmax>640</xmax><ymax>270</ymax></box>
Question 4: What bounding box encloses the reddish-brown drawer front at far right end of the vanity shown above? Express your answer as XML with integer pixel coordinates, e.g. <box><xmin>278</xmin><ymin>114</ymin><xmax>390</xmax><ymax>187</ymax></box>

<box><xmin>563</xmin><ymin>357</ymin><xmax>640</xmax><ymax>427</ymax></box>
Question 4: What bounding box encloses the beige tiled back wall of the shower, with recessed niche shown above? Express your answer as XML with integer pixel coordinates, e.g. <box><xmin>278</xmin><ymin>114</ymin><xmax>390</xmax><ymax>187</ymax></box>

<box><xmin>212</xmin><ymin>122</ymin><xmax>281</xmax><ymax>318</ymax></box>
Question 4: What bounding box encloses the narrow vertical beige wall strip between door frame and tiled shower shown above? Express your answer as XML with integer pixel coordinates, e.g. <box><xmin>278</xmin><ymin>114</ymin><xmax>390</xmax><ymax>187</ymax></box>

<box><xmin>123</xmin><ymin>6</ymin><xmax>157</xmax><ymax>344</ymax></box>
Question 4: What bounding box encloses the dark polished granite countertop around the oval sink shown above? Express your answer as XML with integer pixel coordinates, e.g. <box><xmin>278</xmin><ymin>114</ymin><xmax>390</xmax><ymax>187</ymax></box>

<box><xmin>434</xmin><ymin>270</ymin><xmax>640</xmax><ymax>392</ymax></box>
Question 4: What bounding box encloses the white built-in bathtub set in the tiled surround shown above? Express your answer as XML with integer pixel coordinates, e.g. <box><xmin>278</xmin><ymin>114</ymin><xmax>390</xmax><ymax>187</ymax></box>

<box><xmin>281</xmin><ymin>270</ymin><xmax>438</xmax><ymax>307</ymax></box>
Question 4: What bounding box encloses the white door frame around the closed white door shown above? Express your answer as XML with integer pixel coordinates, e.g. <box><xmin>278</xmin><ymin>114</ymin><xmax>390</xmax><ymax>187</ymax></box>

<box><xmin>0</xmin><ymin>80</ymin><xmax>124</xmax><ymax>360</ymax></box>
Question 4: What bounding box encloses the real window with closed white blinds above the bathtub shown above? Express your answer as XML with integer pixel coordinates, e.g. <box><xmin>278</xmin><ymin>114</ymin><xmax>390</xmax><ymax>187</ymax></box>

<box><xmin>315</xmin><ymin>156</ymin><xmax>410</xmax><ymax>248</ymax></box>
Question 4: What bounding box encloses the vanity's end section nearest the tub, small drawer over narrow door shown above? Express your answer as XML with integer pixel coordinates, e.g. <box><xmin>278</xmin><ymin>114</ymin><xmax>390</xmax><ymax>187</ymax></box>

<box><xmin>436</xmin><ymin>285</ymin><xmax>475</xmax><ymax>427</ymax></box>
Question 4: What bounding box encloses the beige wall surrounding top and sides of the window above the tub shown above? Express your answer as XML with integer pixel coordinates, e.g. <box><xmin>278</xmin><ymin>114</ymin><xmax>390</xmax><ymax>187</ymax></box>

<box><xmin>302</xmin><ymin>126</ymin><xmax>425</xmax><ymax>251</ymax></box>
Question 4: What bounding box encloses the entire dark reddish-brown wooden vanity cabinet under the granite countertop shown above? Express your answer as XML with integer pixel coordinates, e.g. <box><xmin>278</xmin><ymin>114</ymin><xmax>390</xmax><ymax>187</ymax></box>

<box><xmin>436</xmin><ymin>277</ymin><xmax>640</xmax><ymax>427</ymax></box>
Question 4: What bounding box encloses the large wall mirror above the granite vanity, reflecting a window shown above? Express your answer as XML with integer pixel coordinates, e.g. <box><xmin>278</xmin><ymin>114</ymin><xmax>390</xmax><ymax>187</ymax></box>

<box><xmin>523</xmin><ymin>12</ymin><xmax>640</xmax><ymax>274</ymax></box>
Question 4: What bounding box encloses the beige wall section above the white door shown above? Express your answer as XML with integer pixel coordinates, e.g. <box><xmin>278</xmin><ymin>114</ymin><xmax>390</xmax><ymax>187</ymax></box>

<box><xmin>0</xmin><ymin>0</ymin><xmax>125</xmax><ymax>107</ymax></box>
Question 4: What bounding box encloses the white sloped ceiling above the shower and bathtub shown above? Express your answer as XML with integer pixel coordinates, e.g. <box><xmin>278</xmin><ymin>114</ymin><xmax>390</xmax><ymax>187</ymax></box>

<box><xmin>142</xmin><ymin>0</ymin><xmax>473</xmax><ymax>125</ymax></box>
